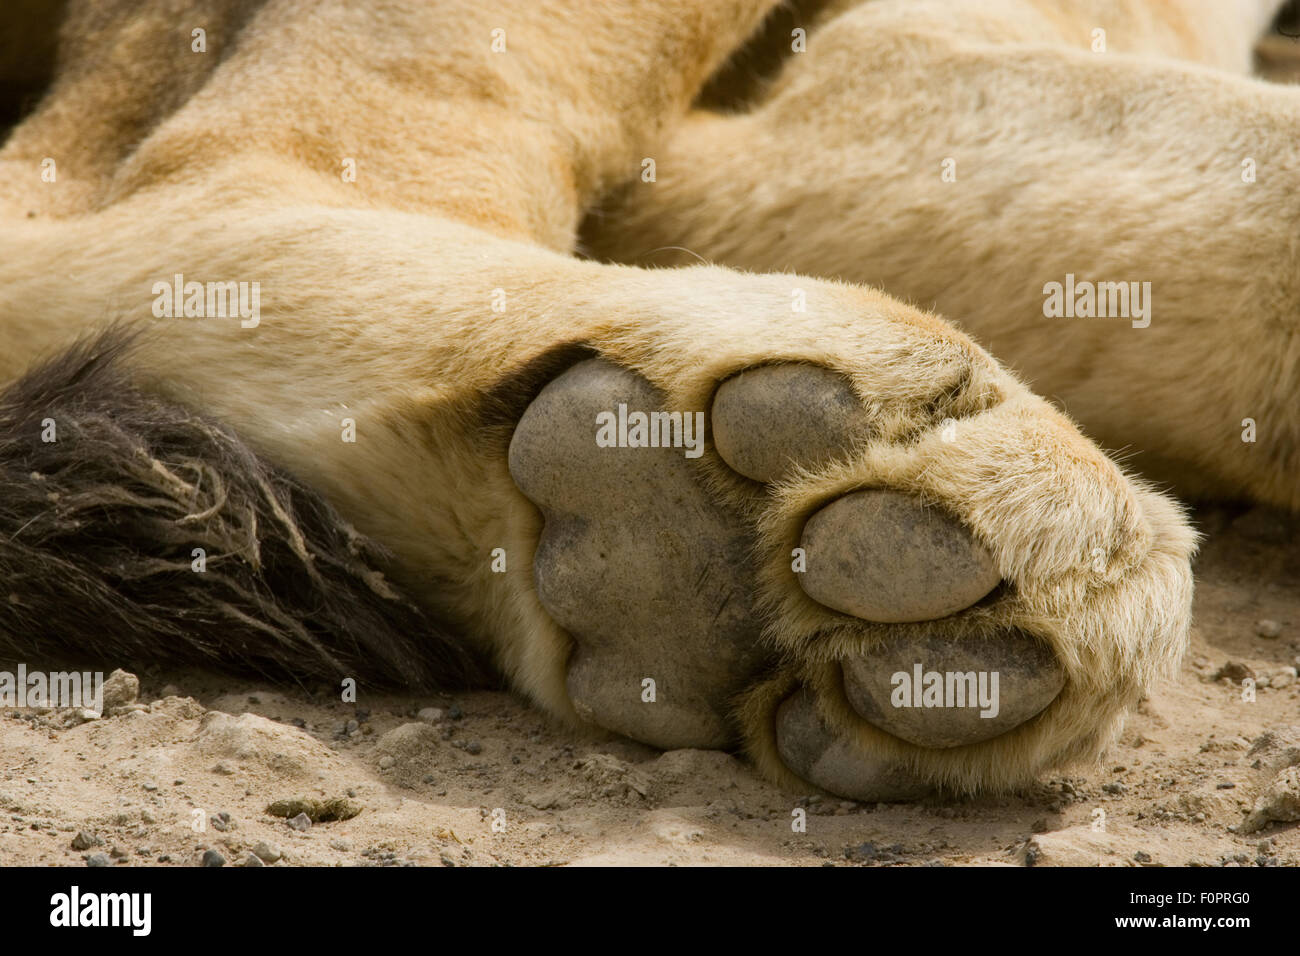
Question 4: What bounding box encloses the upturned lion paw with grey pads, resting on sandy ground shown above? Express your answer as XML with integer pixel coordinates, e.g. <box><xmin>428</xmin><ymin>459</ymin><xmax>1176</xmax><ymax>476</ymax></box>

<box><xmin>510</xmin><ymin>359</ymin><xmax>1190</xmax><ymax>800</ymax></box>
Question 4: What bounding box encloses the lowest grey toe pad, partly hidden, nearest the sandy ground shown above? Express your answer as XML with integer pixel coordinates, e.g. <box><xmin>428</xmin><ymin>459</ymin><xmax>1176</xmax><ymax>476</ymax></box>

<box><xmin>776</xmin><ymin>691</ymin><xmax>933</xmax><ymax>803</ymax></box>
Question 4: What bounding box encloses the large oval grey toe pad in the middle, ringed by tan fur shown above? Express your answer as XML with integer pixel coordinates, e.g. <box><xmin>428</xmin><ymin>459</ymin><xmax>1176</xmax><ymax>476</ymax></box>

<box><xmin>798</xmin><ymin>489</ymin><xmax>998</xmax><ymax>623</ymax></box>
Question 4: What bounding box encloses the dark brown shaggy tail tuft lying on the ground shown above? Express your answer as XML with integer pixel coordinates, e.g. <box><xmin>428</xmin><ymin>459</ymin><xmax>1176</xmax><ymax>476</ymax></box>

<box><xmin>0</xmin><ymin>330</ymin><xmax>480</xmax><ymax>689</ymax></box>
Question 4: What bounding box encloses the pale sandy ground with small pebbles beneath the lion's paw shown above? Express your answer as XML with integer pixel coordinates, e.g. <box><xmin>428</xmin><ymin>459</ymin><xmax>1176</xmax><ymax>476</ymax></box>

<box><xmin>0</xmin><ymin>509</ymin><xmax>1300</xmax><ymax>866</ymax></box>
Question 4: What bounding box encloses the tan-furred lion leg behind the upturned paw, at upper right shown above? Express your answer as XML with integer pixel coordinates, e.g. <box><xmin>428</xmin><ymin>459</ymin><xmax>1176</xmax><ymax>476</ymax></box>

<box><xmin>588</xmin><ymin>0</ymin><xmax>1300</xmax><ymax>509</ymax></box>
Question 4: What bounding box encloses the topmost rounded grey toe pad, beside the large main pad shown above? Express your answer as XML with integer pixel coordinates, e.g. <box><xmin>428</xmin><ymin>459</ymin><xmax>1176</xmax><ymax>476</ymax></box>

<box><xmin>711</xmin><ymin>363</ymin><xmax>867</xmax><ymax>481</ymax></box>
